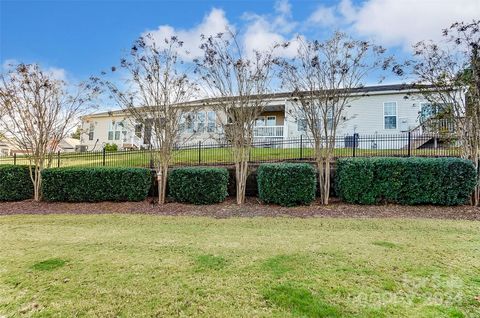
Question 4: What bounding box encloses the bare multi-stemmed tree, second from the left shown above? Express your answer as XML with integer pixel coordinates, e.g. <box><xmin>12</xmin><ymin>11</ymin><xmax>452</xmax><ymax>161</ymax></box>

<box><xmin>102</xmin><ymin>34</ymin><xmax>197</xmax><ymax>204</ymax></box>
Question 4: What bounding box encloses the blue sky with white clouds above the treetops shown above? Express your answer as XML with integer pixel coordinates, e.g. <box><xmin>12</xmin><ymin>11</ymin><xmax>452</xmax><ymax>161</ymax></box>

<box><xmin>0</xmin><ymin>0</ymin><xmax>480</xmax><ymax>83</ymax></box>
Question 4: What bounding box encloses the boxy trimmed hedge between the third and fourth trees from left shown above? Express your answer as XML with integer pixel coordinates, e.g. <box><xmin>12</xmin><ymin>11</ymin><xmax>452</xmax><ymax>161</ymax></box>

<box><xmin>257</xmin><ymin>163</ymin><xmax>317</xmax><ymax>206</ymax></box>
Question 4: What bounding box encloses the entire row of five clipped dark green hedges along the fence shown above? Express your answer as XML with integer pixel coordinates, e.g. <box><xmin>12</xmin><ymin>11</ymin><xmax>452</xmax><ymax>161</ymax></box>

<box><xmin>0</xmin><ymin>158</ymin><xmax>476</xmax><ymax>206</ymax></box>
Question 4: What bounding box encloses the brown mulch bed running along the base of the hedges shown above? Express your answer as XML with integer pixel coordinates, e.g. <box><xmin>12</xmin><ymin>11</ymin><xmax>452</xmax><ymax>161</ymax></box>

<box><xmin>0</xmin><ymin>197</ymin><xmax>480</xmax><ymax>221</ymax></box>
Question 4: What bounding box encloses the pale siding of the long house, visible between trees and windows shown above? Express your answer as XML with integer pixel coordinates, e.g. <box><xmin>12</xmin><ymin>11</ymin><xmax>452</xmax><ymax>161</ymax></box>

<box><xmin>81</xmin><ymin>92</ymin><xmax>436</xmax><ymax>150</ymax></box>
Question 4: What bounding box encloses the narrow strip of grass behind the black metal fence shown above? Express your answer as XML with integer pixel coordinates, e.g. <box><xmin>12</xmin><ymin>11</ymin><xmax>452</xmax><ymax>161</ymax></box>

<box><xmin>0</xmin><ymin>148</ymin><xmax>458</xmax><ymax>167</ymax></box>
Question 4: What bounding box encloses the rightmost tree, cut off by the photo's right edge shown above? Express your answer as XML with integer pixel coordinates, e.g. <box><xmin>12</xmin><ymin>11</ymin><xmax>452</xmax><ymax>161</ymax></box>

<box><xmin>395</xmin><ymin>20</ymin><xmax>480</xmax><ymax>206</ymax></box>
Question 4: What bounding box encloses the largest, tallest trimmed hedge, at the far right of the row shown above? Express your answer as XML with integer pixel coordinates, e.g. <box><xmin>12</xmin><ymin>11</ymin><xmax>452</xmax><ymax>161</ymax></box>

<box><xmin>335</xmin><ymin>158</ymin><xmax>476</xmax><ymax>205</ymax></box>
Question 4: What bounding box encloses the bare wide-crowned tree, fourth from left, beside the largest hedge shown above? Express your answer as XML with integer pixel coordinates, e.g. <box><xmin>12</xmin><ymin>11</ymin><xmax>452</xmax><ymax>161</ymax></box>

<box><xmin>280</xmin><ymin>32</ymin><xmax>392</xmax><ymax>204</ymax></box>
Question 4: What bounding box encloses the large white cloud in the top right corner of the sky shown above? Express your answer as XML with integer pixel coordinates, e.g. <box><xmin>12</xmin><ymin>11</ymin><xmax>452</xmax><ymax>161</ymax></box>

<box><xmin>307</xmin><ymin>0</ymin><xmax>480</xmax><ymax>49</ymax></box>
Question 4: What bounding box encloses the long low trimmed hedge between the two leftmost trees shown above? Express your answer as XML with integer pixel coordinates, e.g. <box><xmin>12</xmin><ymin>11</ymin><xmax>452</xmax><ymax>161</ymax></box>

<box><xmin>42</xmin><ymin>168</ymin><xmax>152</xmax><ymax>202</ymax></box>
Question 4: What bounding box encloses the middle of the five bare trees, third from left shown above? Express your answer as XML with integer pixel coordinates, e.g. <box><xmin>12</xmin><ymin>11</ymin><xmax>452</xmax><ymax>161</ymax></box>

<box><xmin>195</xmin><ymin>30</ymin><xmax>275</xmax><ymax>204</ymax></box>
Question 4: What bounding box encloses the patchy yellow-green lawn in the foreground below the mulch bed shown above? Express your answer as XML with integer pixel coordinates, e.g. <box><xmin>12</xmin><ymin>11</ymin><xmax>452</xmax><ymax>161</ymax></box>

<box><xmin>0</xmin><ymin>215</ymin><xmax>480</xmax><ymax>317</ymax></box>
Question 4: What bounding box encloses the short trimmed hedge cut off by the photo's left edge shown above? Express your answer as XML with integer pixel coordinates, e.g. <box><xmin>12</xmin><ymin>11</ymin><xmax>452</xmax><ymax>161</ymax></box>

<box><xmin>0</xmin><ymin>165</ymin><xmax>33</xmax><ymax>201</ymax></box>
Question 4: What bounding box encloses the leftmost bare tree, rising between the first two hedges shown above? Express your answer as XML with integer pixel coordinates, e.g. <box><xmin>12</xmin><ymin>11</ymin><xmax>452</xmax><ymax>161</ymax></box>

<box><xmin>0</xmin><ymin>64</ymin><xmax>98</xmax><ymax>201</ymax></box>
